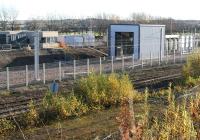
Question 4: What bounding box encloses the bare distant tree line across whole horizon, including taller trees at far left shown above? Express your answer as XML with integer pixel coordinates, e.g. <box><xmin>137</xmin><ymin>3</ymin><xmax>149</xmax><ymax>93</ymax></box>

<box><xmin>0</xmin><ymin>8</ymin><xmax>200</xmax><ymax>36</ymax></box>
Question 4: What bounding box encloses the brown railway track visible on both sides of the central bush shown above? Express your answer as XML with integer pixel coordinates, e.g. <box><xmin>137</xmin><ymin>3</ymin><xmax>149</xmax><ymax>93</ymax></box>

<box><xmin>0</xmin><ymin>66</ymin><xmax>184</xmax><ymax>118</ymax></box>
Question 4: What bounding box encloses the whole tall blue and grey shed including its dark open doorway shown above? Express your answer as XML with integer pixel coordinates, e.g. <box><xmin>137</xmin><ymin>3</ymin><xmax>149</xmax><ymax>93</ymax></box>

<box><xmin>108</xmin><ymin>24</ymin><xmax>165</xmax><ymax>59</ymax></box>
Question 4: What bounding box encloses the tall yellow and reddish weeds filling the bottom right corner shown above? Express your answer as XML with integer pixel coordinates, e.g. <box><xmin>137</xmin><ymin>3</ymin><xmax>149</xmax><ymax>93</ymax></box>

<box><xmin>117</xmin><ymin>83</ymin><xmax>200</xmax><ymax>140</ymax></box>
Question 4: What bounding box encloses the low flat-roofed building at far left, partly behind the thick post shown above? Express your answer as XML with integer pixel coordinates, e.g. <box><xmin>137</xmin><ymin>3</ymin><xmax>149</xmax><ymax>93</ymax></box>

<box><xmin>0</xmin><ymin>30</ymin><xmax>59</xmax><ymax>50</ymax></box>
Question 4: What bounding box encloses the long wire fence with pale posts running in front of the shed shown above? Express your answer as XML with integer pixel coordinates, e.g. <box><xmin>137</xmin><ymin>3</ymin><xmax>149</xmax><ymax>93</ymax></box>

<box><xmin>0</xmin><ymin>53</ymin><xmax>187</xmax><ymax>90</ymax></box>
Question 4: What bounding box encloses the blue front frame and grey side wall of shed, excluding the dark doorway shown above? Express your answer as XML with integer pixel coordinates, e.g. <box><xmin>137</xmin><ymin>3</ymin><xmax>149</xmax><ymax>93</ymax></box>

<box><xmin>108</xmin><ymin>24</ymin><xmax>165</xmax><ymax>59</ymax></box>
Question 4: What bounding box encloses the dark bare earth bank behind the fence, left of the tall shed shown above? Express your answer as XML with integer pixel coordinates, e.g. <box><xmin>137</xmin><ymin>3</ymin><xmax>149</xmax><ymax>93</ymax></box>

<box><xmin>0</xmin><ymin>47</ymin><xmax>108</xmax><ymax>69</ymax></box>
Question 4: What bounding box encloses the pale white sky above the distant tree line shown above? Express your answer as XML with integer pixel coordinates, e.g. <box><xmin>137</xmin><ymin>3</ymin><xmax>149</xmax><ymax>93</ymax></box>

<box><xmin>0</xmin><ymin>0</ymin><xmax>200</xmax><ymax>20</ymax></box>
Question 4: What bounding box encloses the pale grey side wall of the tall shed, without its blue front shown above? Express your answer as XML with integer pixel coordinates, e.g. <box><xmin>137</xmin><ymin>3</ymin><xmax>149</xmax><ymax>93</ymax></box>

<box><xmin>140</xmin><ymin>25</ymin><xmax>165</xmax><ymax>59</ymax></box>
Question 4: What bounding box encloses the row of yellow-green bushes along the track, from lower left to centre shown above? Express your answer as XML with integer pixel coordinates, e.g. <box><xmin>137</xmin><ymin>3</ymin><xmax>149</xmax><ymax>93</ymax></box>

<box><xmin>0</xmin><ymin>74</ymin><xmax>142</xmax><ymax>133</ymax></box>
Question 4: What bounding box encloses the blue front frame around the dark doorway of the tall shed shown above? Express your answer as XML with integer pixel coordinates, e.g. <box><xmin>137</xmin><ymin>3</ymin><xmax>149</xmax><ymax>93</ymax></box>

<box><xmin>108</xmin><ymin>24</ymin><xmax>140</xmax><ymax>59</ymax></box>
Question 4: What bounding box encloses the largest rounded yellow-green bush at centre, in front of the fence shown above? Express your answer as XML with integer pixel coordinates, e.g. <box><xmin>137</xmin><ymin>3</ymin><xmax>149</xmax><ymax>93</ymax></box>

<box><xmin>75</xmin><ymin>74</ymin><xmax>139</xmax><ymax>107</ymax></box>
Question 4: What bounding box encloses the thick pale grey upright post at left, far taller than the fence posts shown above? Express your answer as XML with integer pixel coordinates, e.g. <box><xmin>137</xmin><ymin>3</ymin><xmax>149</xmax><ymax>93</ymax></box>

<box><xmin>34</xmin><ymin>31</ymin><xmax>40</xmax><ymax>81</ymax></box>
